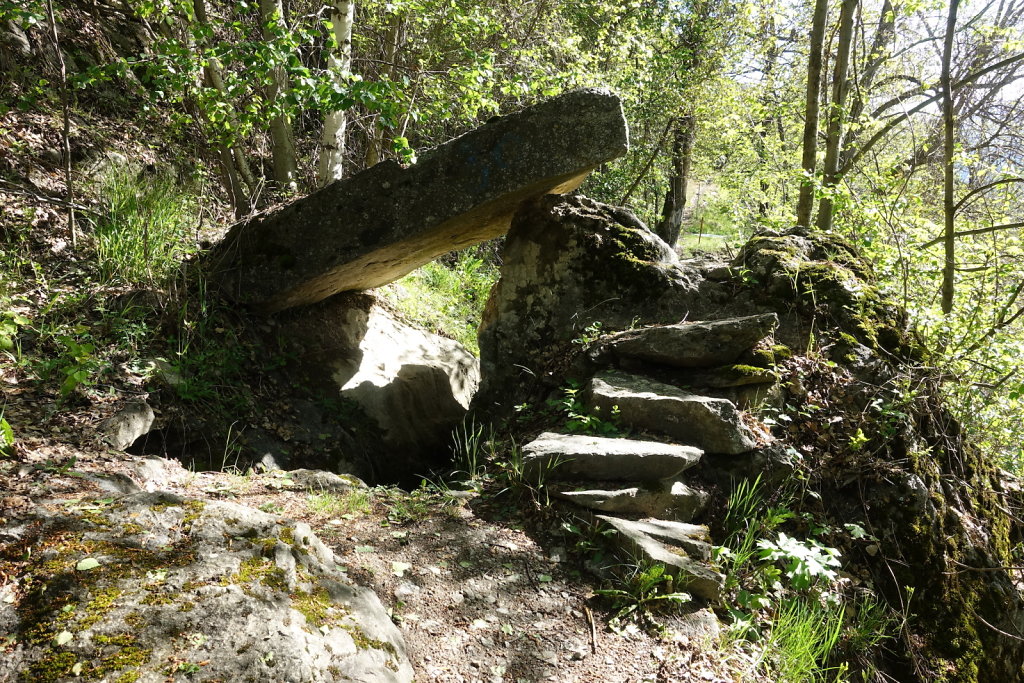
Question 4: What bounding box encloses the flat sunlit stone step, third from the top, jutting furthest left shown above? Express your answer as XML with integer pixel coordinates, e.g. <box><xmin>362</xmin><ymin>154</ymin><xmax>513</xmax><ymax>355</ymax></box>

<box><xmin>522</xmin><ymin>432</ymin><xmax>703</xmax><ymax>481</ymax></box>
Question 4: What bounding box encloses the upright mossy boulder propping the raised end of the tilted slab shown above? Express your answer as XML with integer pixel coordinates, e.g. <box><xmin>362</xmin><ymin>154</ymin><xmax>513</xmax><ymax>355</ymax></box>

<box><xmin>474</xmin><ymin>197</ymin><xmax>696</xmax><ymax>415</ymax></box>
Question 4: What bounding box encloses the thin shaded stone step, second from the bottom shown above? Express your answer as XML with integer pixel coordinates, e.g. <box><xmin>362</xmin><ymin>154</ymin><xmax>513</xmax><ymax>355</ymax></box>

<box><xmin>556</xmin><ymin>481</ymin><xmax>708</xmax><ymax>522</ymax></box>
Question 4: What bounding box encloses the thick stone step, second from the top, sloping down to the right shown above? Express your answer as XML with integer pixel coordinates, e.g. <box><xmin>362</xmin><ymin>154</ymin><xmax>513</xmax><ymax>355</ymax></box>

<box><xmin>583</xmin><ymin>371</ymin><xmax>757</xmax><ymax>455</ymax></box>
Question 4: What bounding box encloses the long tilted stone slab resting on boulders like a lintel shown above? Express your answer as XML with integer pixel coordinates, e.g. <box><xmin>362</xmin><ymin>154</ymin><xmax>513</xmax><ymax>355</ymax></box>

<box><xmin>212</xmin><ymin>89</ymin><xmax>629</xmax><ymax>311</ymax></box>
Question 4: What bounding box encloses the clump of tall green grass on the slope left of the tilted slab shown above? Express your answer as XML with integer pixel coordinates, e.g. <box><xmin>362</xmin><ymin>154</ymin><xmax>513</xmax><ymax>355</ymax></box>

<box><xmin>95</xmin><ymin>166</ymin><xmax>200</xmax><ymax>286</ymax></box>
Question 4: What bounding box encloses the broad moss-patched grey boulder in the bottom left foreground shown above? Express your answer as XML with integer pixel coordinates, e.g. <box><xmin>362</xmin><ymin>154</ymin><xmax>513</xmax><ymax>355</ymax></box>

<box><xmin>0</xmin><ymin>494</ymin><xmax>413</xmax><ymax>683</ymax></box>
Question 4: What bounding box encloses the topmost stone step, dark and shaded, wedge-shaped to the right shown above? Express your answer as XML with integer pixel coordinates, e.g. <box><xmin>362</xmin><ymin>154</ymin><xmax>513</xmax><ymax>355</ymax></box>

<box><xmin>596</xmin><ymin>313</ymin><xmax>778</xmax><ymax>368</ymax></box>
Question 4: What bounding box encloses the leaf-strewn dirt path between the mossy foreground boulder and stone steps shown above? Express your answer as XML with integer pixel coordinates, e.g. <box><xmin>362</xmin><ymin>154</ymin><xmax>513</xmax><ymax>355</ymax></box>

<box><xmin>0</xmin><ymin>393</ymin><xmax>742</xmax><ymax>682</ymax></box>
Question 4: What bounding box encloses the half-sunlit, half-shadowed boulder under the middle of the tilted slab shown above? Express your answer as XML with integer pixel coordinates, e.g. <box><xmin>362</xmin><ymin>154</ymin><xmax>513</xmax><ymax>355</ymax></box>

<box><xmin>279</xmin><ymin>294</ymin><xmax>479</xmax><ymax>480</ymax></box>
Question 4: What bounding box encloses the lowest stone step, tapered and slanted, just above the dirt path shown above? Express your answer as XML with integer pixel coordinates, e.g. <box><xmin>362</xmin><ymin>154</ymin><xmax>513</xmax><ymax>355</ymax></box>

<box><xmin>597</xmin><ymin>515</ymin><xmax>725</xmax><ymax>603</ymax></box>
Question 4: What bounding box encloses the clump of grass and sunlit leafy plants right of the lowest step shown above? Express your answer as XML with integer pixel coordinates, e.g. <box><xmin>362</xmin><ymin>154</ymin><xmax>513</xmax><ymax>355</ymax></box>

<box><xmin>716</xmin><ymin>476</ymin><xmax>896</xmax><ymax>681</ymax></box>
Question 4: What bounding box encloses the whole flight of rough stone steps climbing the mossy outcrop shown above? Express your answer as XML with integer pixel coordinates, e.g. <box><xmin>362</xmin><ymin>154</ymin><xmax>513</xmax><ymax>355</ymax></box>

<box><xmin>523</xmin><ymin>313</ymin><xmax>778</xmax><ymax>603</ymax></box>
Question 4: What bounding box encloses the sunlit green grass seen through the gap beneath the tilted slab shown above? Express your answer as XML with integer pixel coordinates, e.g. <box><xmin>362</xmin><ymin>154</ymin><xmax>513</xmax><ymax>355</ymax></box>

<box><xmin>385</xmin><ymin>250</ymin><xmax>498</xmax><ymax>354</ymax></box>
